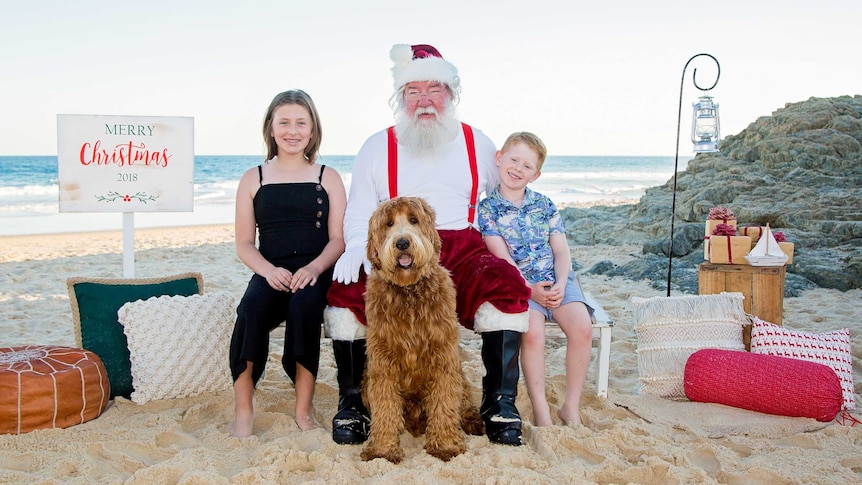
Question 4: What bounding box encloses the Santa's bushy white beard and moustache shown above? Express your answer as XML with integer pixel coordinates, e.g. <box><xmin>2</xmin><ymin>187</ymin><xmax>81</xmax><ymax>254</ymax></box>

<box><xmin>395</xmin><ymin>106</ymin><xmax>459</xmax><ymax>155</ymax></box>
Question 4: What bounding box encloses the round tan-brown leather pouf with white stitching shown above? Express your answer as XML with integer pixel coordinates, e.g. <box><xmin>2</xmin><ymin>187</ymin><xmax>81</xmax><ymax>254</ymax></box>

<box><xmin>0</xmin><ymin>345</ymin><xmax>111</xmax><ymax>434</ymax></box>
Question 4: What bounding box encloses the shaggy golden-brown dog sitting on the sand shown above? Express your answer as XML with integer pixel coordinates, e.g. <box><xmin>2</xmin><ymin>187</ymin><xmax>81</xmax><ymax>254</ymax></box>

<box><xmin>362</xmin><ymin>197</ymin><xmax>484</xmax><ymax>463</ymax></box>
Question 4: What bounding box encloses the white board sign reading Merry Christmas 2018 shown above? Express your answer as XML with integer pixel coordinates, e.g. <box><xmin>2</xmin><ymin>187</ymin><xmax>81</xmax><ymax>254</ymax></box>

<box><xmin>57</xmin><ymin>115</ymin><xmax>194</xmax><ymax>212</ymax></box>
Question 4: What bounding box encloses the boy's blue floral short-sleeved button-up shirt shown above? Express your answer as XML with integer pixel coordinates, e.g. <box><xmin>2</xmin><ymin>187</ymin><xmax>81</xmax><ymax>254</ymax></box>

<box><xmin>479</xmin><ymin>187</ymin><xmax>566</xmax><ymax>284</ymax></box>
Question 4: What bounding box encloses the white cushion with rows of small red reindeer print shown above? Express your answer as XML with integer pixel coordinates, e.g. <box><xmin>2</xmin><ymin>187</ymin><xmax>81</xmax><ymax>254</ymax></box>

<box><xmin>751</xmin><ymin>317</ymin><xmax>856</xmax><ymax>410</ymax></box>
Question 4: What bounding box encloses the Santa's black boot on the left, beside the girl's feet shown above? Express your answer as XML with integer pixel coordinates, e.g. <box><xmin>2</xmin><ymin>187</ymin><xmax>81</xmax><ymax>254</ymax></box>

<box><xmin>332</xmin><ymin>340</ymin><xmax>371</xmax><ymax>445</ymax></box>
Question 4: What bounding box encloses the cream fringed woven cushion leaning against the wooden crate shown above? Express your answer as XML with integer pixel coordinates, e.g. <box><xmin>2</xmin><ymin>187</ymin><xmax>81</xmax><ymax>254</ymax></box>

<box><xmin>631</xmin><ymin>293</ymin><xmax>749</xmax><ymax>400</ymax></box>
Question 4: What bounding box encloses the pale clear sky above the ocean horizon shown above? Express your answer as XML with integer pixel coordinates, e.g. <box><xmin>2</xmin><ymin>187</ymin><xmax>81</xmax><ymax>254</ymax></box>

<box><xmin>0</xmin><ymin>0</ymin><xmax>862</xmax><ymax>156</ymax></box>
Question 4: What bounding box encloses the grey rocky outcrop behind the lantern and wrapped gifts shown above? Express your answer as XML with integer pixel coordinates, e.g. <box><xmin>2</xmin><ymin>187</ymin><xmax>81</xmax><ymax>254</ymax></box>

<box><xmin>562</xmin><ymin>95</ymin><xmax>862</xmax><ymax>296</ymax></box>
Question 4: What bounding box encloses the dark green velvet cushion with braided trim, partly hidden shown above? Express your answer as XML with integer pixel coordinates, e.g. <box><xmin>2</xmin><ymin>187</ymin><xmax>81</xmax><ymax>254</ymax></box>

<box><xmin>66</xmin><ymin>273</ymin><xmax>204</xmax><ymax>399</ymax></box>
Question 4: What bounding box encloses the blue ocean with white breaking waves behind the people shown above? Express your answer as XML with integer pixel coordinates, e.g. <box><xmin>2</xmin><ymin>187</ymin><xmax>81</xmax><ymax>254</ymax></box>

<box><xmin>0</xmin><ymin>155</ymin><xmax>690</xmax><ymax>236</ymax></box>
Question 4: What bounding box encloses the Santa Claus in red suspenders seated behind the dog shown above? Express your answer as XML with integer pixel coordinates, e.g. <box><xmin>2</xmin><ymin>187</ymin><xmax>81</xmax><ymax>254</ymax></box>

<box><xmin>324</xmin><ymin>44</ymin><xmax>530</xmax><ymax>446</ymax></box>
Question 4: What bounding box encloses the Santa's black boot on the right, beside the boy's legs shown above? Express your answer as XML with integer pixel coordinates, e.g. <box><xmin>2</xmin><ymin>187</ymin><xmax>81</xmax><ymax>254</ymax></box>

<box><xmin>480</xmin><ymin>330</ymin><xmax>521</xmax><ymax>446</ymax></box>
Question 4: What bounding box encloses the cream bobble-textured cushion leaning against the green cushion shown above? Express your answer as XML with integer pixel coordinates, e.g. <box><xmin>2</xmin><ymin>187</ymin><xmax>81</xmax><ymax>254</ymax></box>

<box><xmin>117</xmin><ymin>292</ymin><xmax>236</xmax><ymax>404</ymax></box>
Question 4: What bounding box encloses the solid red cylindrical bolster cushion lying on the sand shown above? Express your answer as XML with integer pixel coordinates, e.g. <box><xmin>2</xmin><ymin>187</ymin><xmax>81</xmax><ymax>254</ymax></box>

<box><xmin>683</xmin><ymin>349</ymin><xmax>843</xmax><ymax>422</ymax></box>
